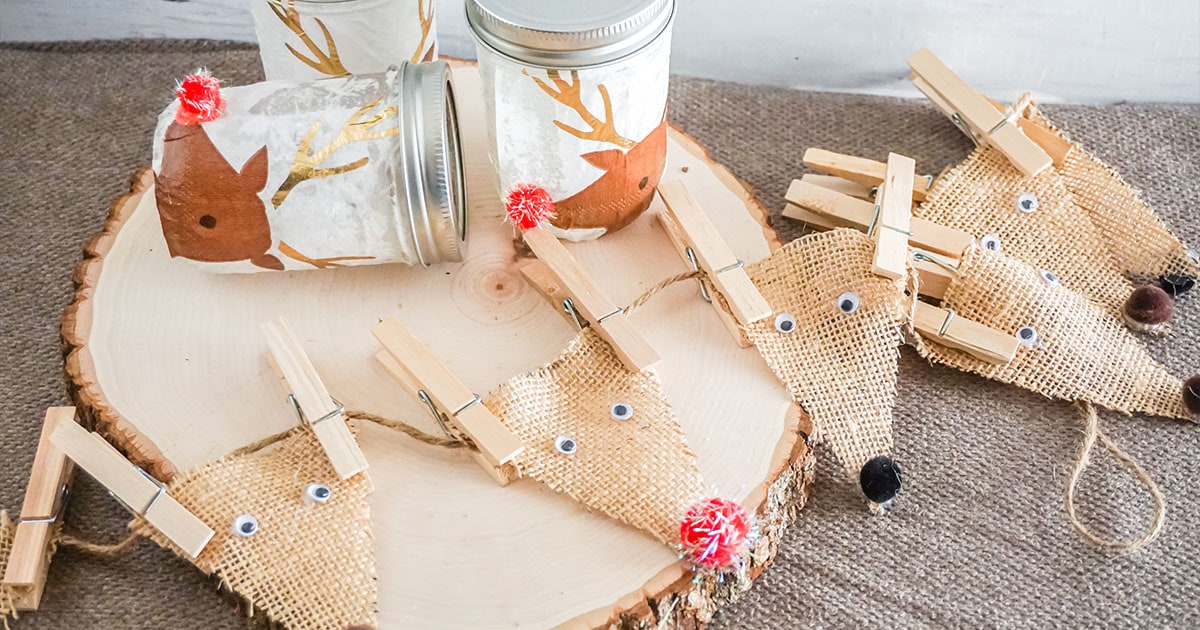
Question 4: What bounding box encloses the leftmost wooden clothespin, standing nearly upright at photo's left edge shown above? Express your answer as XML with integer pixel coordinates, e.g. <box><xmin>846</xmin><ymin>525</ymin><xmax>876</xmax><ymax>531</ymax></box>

<box><xmin>0</xmin><ymin>407</ymin><xmax>76</xmax><ymax>611</ymax></box>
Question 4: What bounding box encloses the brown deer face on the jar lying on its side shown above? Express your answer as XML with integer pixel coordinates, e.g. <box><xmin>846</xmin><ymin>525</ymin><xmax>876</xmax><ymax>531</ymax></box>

<box><xmin>155</xmin><ymin>122</ymin><xmax>283</xmax><ymax>270</ymax></box>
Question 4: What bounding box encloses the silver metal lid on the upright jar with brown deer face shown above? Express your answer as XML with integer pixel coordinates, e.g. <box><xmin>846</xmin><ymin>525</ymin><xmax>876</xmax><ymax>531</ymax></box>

<box><xmin>467</xmin><ymin>0</ymin><xmax>676</xmax><ymax>68</ymax></box>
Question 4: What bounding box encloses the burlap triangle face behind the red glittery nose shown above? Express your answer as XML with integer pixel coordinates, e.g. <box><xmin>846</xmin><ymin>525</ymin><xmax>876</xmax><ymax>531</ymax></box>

<box><xmin>485</xmin><ymin>328</ymin><xmax>706</xmax><ymax>544</ymax></box>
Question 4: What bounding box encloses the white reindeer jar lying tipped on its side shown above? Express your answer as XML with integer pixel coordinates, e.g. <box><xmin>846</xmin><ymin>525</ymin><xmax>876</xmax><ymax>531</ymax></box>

<box><xmin>154</xmin><ymin>61</ymin><xmax>467</xmax><ymax>272</ymax></box>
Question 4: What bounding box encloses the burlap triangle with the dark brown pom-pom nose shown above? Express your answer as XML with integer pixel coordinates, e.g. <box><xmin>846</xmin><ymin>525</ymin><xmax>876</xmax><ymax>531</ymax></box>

<box><xmin>913</xmin><ymin>145</ymin><xmax>1133</xmax><ymax>317</ymax></box>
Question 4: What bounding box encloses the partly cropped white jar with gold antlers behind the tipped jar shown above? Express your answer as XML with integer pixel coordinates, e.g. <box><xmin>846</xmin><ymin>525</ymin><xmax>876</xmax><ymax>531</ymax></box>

<box><xmin>250</xmin><ymin>0</ymin><xmax>438</xmax><ymax>80</ymax></box>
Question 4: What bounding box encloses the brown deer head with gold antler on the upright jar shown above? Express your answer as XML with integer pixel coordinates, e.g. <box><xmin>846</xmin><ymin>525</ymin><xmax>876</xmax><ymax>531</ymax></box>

<box><xmin>533</xmin><ymin>71</ymin><xmax>667</xmax><ymax>233</ymax></box>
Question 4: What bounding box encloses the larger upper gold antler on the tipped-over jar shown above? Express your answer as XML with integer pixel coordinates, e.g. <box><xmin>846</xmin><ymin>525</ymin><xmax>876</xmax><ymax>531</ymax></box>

<box><xmin>271</xmin><ymin>96</ymin><xmax>400</xmax><ymax>208</ymax></box>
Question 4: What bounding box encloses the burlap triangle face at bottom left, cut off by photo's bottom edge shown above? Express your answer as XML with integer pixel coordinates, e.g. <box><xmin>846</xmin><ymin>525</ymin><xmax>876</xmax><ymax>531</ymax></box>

<box><xmin>134</xmin><ymin>430</ymin><xmax>377</xmax><ymax>630</ymax></box>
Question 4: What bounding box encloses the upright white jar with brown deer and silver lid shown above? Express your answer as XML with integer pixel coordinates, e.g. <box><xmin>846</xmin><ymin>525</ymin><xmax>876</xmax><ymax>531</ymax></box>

<box><xmin>467</xmin><ymin>0</ymin><xmax>674</xmax><ymax>240</ymax></box>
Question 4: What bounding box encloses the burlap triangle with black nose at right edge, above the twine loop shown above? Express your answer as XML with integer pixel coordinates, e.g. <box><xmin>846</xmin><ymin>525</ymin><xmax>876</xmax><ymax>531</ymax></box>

<box><xmin>920</xmin><ymin>247</ymin><xmax>1190</xmax><ymax>419</ymax></box>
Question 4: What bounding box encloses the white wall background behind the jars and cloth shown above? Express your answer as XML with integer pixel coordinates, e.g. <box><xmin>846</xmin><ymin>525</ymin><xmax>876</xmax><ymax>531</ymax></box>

<box><xmin>0</xmin><ymin>0</ymin><xmax>1200</xmax><ymax>102</ymax></box>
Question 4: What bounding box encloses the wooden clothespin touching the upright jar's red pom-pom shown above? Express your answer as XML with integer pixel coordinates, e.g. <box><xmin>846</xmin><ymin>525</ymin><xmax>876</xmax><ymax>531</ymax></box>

<box><xmin>524</xmin><ymin>227</ymin><xmax>661</xmax><ymax>372</ymax></box>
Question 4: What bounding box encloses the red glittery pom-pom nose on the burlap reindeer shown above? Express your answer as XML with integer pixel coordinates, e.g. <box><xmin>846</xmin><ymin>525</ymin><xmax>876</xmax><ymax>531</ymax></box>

<box><xmin>679</xmin><ymin>498</ymin><xmax>751</xmax><ymax>568</ymax></box>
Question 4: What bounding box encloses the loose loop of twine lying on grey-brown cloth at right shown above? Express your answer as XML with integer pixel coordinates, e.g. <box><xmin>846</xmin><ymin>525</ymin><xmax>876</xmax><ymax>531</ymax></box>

<box><xmin>1064</xmin><ymin>401</ymin><xmax>1166</xmax><ymax>552</ymax></box>
